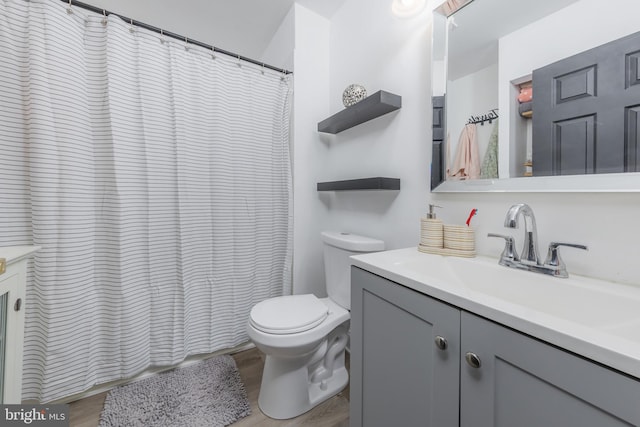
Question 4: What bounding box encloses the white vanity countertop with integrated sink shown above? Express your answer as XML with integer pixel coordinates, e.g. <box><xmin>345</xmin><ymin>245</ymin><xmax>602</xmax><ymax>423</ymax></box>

<box><xmin>351</xmin><ymin>248</ymin><xmax>640</xmax><ymax>378</ymax></box>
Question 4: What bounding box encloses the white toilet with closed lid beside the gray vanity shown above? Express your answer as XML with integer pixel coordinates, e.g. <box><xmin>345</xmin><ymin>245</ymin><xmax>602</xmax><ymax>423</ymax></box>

<box><xmin>247</xmin><ymin>231</ymin><xmax>384</xmax><ymax>419</ymax></box>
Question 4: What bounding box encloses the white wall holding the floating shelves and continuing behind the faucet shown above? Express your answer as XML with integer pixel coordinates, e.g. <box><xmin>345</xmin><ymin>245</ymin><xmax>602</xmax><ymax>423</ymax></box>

<box><xmin>318</xmin><ymin>0</ymin><xmax>640</xmax><ymax>290</ymax></box>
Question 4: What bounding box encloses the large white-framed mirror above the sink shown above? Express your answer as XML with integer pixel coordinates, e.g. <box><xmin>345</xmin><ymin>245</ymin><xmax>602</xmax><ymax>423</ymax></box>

<box><xmin>432</xmin><ymin>0</ymin><xmax>640</xmax><ymax>192</ymax></box>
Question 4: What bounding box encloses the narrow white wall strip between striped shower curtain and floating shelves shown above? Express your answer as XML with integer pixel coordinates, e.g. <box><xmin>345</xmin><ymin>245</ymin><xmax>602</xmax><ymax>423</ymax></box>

<box><xmin>293</xmin><ymin>5</ymin><xmax>330</xmax><ymax>296</ymax></box>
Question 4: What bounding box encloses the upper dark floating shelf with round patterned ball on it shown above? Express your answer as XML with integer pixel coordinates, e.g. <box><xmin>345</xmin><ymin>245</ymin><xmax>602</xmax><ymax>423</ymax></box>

<box><xmin>318</xmin><ymin>90</ymin><xmax>402</xmax><ymax>134</ymax></box>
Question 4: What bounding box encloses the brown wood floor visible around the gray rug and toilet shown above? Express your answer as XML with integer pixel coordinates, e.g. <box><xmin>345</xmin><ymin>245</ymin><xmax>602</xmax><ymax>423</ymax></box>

<box><xmin>69</xmin><ymin>349</ymin><xmax>349</xmax><ymax>427</ymax></box>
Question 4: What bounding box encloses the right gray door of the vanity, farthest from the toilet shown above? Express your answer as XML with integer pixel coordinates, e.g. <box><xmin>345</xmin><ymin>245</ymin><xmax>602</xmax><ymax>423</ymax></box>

<box><xmin>460</xmin><ymin>312</ymin><xmax>640</xmax><ymax>427</ymax></box>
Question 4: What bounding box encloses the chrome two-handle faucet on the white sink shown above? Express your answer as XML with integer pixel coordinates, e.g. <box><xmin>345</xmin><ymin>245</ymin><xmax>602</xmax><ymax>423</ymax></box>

<box><xmin>487</xmin><ymin>203</ymin><xmax>588</xmax><ymax>277</ymax></box>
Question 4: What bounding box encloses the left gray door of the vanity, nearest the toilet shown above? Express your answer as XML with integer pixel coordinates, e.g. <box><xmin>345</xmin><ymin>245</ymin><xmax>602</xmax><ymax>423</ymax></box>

<box><xmin>350</xmin><ymin>267</ymin><xmax>460</xmax><ymax>427</ymax></box>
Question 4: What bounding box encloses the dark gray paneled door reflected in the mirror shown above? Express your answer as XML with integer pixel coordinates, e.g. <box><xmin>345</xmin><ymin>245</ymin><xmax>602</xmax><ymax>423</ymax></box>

<box><xmin>532</xmin><ymin>33</ymin><xmax>640</xmax><ymax>176</ymax></box>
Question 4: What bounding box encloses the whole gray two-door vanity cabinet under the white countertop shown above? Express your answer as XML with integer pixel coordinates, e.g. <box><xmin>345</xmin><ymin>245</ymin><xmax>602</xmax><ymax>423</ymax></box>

<box><xmin>350</xmin><ymin>267</ymin><xmax>640</xmax><ymax>427</ymax></box>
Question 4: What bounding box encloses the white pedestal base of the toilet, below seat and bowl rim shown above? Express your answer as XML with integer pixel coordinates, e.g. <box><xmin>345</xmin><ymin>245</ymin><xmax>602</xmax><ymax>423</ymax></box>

<box><xmin>258</xmin><ymin>327</ymin><xmax>349</xmax><ymax>420</ymax></box>
